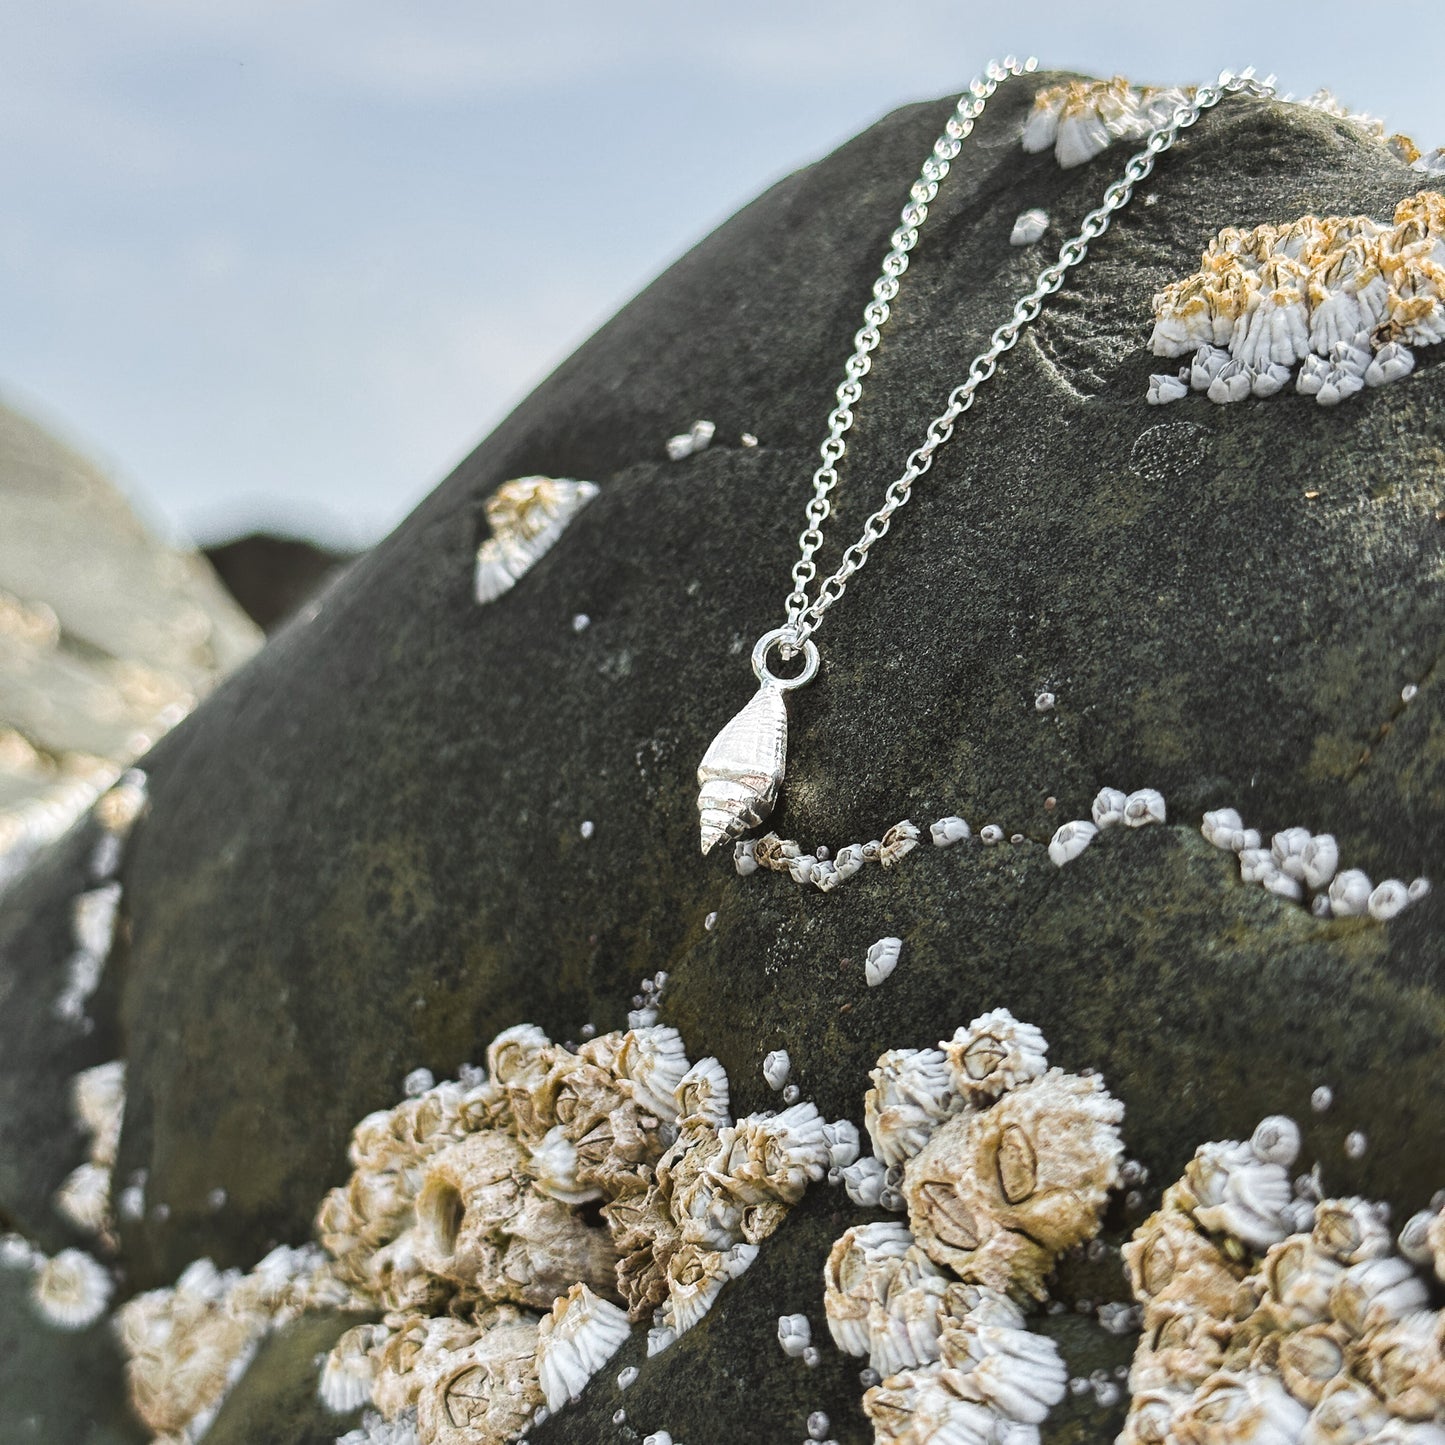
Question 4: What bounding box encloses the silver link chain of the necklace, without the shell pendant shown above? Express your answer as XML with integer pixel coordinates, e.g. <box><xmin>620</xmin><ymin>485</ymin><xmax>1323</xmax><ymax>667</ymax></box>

<box><xmin>779</xmin><ymin>65</ymin><xmax>1274</xmax><ymax>657</ymax></box>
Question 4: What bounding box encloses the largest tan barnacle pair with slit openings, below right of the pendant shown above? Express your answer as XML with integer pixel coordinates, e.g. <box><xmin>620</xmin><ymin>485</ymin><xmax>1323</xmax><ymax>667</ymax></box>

<box><xmin>903</xmin><ymin>1069</ymin><xmax>1124</xmax><ymax>1298</ymax></box>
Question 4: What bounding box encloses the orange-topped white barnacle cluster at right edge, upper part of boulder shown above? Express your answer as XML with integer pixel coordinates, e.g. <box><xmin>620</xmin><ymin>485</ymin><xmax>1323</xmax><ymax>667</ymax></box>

<box><xmin>1149</xmin><ymin>191</ymin><xmax>1445</xmax><ymax>406</ymax></box>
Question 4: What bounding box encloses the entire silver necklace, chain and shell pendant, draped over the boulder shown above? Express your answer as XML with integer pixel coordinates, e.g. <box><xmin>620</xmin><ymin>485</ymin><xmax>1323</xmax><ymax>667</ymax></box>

<box><xmin>698</xmin><ymin>56</ymin><xmax>1274</xmax><ymax>853</ymax></box>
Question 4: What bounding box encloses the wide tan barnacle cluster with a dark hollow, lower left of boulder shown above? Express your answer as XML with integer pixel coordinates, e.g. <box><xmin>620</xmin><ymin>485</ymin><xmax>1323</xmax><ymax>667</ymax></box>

<box><xmin>318</xmin><ymin>1025</ymin><xmax>838</xmax><ymax>1445</ymax></box>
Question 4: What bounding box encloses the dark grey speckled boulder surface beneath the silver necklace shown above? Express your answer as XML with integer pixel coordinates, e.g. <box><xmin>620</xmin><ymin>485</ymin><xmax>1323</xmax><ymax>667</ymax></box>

<box><xmin>0</xmin><ymin>81</ymin><xmax>1445</xmax><ymax>1445</ymax></box>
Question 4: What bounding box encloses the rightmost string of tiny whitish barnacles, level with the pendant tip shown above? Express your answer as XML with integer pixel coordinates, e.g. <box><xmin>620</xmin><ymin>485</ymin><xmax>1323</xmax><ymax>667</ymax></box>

<box><xmin>1199</xmin><ymin>808</ymin><xmax>1431</xmax><ymax>922</ymax></box>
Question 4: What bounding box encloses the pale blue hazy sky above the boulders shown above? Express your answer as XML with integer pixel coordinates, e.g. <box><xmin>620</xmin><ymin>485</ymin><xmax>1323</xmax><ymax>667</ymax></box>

<box><xmin>0</xmin><ymin>0</ymin><xmax>1445</xmax><ymax>546</ymax></box>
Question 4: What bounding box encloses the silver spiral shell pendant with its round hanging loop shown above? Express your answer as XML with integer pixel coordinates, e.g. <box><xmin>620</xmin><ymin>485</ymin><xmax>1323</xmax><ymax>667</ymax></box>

<box><xmin>698</xmin><ymin>627</ymin><xmax>818</xmax><ymax>854</ymax></box>
